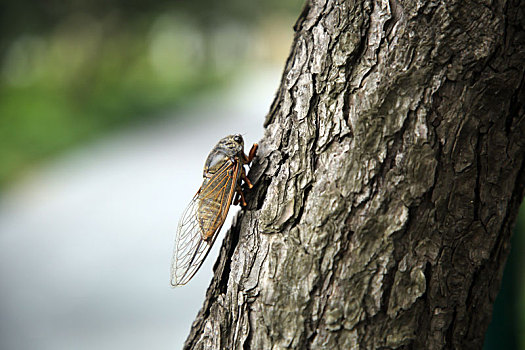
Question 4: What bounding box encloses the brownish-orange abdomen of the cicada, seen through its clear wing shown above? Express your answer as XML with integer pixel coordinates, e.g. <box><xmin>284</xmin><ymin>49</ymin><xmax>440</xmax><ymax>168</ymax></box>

<box><xmin>197</xmin><ymin>153</ymin><xmax>242</xmax><ymax>241</ymax></box>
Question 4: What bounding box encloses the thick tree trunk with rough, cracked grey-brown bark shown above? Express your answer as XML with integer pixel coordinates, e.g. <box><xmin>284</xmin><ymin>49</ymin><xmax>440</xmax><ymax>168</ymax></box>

<box><xmin>185</xmin><ymin>0</ymin><xmax>525</xmax><ymax>349</ymax></box>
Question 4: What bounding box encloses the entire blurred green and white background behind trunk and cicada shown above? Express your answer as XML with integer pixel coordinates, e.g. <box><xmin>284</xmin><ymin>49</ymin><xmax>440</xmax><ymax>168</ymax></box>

<box><xmin>0</xmin><ymin>0</ymin><xmax>525</xmax><ymax>350</ymax></box>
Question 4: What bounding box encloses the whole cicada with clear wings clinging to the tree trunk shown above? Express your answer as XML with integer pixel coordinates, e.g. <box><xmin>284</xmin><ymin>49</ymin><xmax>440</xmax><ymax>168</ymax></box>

<box><xmin>171</xmin><ymin>134</ymin><xmax>257</xmax><ymax>287</ymax></box>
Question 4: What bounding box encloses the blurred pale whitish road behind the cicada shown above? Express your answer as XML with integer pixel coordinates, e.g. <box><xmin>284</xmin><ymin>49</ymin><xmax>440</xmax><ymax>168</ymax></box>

<box><xmin>0</xmin><ymin>69</ymin><xmax>280</xmax><ymax>350</ymax></box>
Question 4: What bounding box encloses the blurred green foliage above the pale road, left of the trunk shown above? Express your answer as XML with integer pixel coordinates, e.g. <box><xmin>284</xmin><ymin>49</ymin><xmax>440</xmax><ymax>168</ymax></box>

<box><xmin>0</xmin><ymin>0</ymin><xmax>302</xmax><ymax>189</ymax></box>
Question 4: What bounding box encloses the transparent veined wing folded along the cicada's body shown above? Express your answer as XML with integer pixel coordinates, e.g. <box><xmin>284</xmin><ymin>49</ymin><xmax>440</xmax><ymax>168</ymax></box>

<box><xmin>171</xmin><ymin>163</ymin><xmax>240</xmax><ymax>287</ymax></box>
